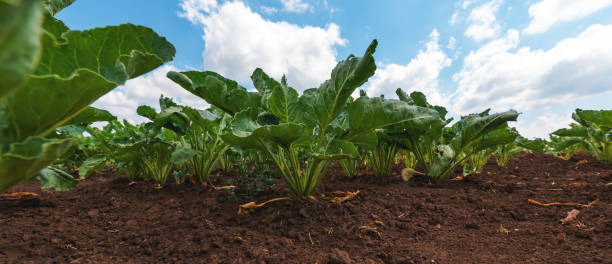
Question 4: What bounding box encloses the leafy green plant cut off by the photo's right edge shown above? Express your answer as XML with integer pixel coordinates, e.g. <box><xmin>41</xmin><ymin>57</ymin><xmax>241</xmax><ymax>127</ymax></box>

<box><xmin>551</xmin><ymin>109</ymin><xmax>612</xmax><ymax>163</ymax></box>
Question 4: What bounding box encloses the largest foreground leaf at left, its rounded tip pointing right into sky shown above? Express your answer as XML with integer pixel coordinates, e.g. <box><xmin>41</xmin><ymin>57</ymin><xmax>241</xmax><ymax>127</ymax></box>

<box><xmin>0</xmin><ymin>24</ymin><xmax>174</xmax><ymax>142</ymax></box>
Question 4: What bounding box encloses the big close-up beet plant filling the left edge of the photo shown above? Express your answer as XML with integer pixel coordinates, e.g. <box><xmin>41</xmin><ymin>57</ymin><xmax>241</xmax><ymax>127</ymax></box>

<box><xmin>0</xmin><ymin>0</ymin><xmax>175</xmax><ymax>192</ymax></box>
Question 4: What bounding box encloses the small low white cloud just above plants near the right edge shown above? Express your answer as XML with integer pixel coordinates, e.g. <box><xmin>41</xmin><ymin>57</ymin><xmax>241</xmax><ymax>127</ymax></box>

<box><xmin>516</xmin><ymin>111</ymin><xmax>573</xmax><ymax>139</ymax></box>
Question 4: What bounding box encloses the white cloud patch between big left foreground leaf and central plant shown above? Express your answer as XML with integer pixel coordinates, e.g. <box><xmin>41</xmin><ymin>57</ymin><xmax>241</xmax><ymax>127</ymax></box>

<box><xmin>93</xmin><ymin>65</ymin><xmax>208</xmax><ymax>123</ymax></box>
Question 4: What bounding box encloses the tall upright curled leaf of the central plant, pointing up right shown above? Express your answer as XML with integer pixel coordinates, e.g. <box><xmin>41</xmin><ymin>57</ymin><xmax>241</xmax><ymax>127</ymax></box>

<box><xmin>299</xmin><ymin>40</ymin><xmax>378</xmax><ymax>131</ymax></box>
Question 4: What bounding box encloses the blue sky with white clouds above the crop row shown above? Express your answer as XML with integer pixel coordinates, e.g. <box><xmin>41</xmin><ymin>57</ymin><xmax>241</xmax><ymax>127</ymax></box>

<box><xmin>58</xmin><ymin>0</ymin><xmax>612</xmax><ymax>137</ymax></box>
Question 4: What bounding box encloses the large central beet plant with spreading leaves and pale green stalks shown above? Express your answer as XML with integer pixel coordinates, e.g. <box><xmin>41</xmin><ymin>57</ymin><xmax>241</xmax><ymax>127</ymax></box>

<box><xmin>168</xmin><ymin>40</ymin><xmax>438</xmax><ymax>197</ymax></box>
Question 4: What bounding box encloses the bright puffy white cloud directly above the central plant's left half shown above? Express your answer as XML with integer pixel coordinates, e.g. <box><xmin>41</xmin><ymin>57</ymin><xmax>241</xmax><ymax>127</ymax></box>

<box><xmin>181</xmin><ymin>2</ymin><xmax>346</xmax><ymax>90</ymax></box>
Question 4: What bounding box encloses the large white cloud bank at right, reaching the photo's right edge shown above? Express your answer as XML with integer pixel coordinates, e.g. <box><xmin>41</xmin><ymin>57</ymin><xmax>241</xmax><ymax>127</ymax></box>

<box><xmin>453</xmin><ymin>25</ymin><xmax>612</xmax><ymax>113</ymax></box>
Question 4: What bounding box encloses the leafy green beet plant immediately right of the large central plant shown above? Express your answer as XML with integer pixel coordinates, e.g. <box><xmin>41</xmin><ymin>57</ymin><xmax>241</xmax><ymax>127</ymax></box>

<box><xmin>386</xmin><ymin>89</ymin><xmax>518</xmax><ymax>179</ymax></box>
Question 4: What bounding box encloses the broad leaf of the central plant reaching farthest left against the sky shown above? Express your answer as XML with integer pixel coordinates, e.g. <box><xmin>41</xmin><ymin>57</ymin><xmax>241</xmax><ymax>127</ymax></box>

<box><xmin>167</xmin><ymin>71</ymin><xmax>261</xmax><ymax>115</ymax></box>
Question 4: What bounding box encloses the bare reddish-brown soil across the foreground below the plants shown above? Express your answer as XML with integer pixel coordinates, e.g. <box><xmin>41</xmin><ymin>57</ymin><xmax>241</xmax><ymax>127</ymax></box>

<box><xmin>0</xmin><ymin>154</ymin><xmax>612</xmax><ymax>263</ymax></box>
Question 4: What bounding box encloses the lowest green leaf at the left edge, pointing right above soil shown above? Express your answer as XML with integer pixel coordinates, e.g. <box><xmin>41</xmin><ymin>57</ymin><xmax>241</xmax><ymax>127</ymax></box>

<box><xmin>0</xmin><ymin>137</ymin><xmax>75</xmax><ymax>193</ymax></box>
